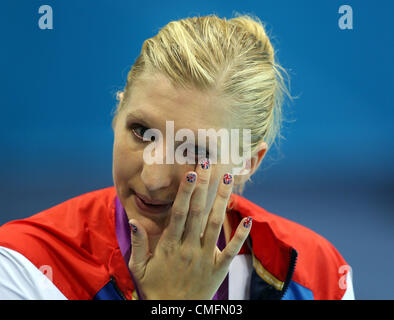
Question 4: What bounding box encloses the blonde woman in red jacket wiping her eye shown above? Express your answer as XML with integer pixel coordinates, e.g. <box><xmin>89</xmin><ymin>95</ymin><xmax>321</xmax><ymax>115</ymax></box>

<box><xmin>0</xmin><ymin>15</ymin><xmax>353</xmax><ymax>299</ymax></box>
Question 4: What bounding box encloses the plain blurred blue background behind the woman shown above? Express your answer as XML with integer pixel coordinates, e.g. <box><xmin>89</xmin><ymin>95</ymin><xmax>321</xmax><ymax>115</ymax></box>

<box><xmin>0</xmin><ymin>0</ymin><xmax>394</xmax><ymax>299</ymax></box>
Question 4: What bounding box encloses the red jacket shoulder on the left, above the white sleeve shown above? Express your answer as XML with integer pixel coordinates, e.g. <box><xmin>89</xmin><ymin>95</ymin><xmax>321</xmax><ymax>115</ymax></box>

<box><xmin>0</xmin><ymin>187</ymin><xmax>117</xmax><ymax>299</ymax></box>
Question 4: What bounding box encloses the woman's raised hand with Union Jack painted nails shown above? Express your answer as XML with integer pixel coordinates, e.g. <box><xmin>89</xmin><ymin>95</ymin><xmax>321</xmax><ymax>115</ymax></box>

<box><xmin>129</xmin><ymin>162</ymin><xmax>251</xmax><ymax>300</ymax></box>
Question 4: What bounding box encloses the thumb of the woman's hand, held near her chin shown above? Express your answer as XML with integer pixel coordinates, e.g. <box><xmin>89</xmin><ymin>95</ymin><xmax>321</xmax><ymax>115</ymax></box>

<box><xmin>129</xmin><ymin>219</ymin><xmax>151</xmax><ymax>279</ymax></box>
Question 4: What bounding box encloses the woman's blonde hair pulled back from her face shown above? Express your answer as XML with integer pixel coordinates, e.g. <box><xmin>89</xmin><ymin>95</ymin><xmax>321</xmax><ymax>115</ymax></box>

<box><xmin>112</xmin><ymin>14</ymin><xmax>291</xmax><ymax>194</ymax></box>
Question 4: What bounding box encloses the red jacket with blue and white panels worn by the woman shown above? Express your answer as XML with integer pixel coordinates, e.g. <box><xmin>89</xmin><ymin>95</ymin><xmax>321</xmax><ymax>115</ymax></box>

<box><xmin>0</xmin><ymin>186</ymin><xmax>354</xmax><ymax>299</ymax></box>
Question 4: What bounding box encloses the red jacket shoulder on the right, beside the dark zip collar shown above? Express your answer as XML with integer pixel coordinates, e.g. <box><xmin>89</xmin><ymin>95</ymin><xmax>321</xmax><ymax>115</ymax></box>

<box><xmin>229</xmin><ymin>195</ymin><xmax>348</xmax><ymax>299</ymax></box>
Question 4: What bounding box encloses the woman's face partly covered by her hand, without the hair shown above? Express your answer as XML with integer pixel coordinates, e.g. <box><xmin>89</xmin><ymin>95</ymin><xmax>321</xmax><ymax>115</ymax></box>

<box><xmin>113</xmin><ymin>75</ymin><xmax>239</xmax><ymax>236</ymax></box>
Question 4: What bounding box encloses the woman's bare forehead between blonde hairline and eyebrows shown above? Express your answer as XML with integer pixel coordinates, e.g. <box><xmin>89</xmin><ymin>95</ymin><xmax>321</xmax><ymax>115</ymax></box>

<box><xmin>125</xmin><ymin>77</ymin><xmax>234</xmax><ymax>130</ymax></box>
